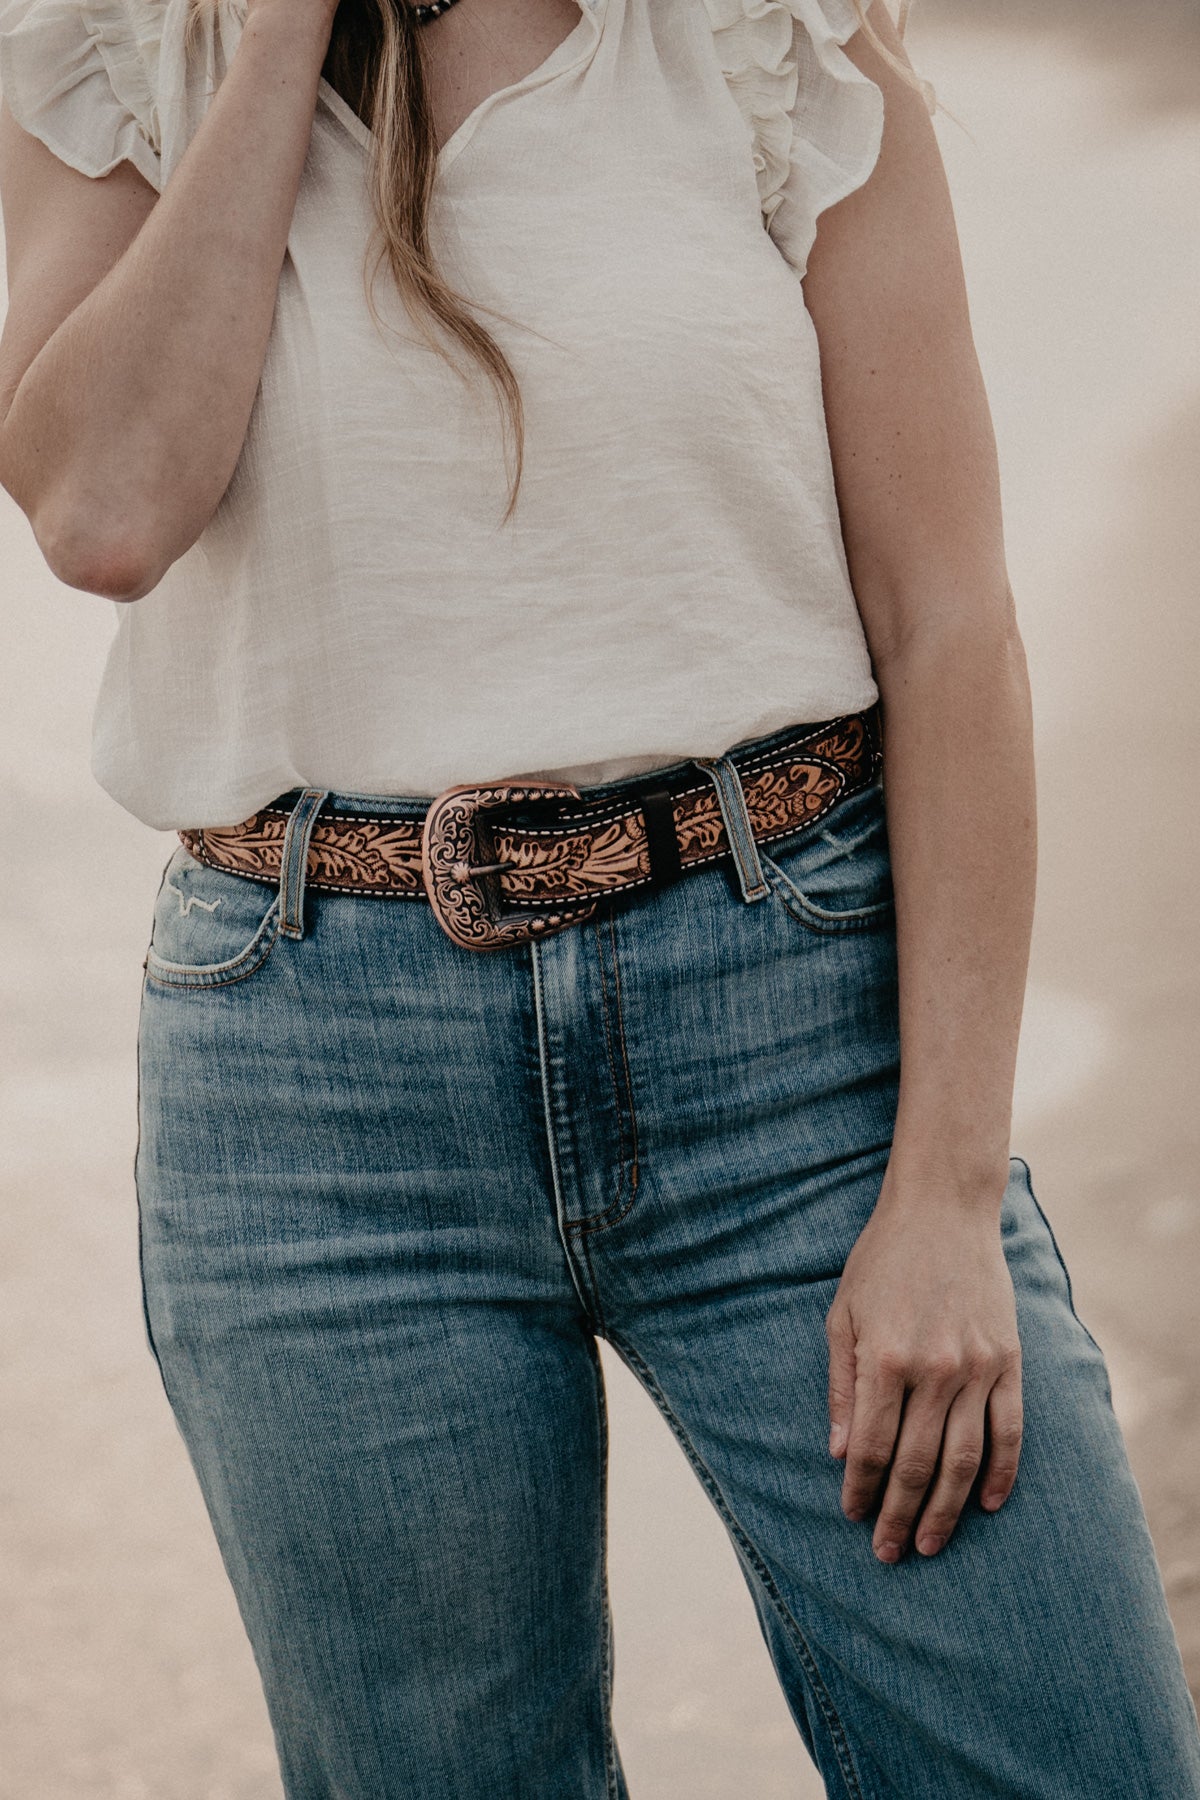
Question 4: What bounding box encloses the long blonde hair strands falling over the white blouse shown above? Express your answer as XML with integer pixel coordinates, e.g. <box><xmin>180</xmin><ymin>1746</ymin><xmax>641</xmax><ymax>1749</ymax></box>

<box><xmin>193</xmin><ymin>0</ymin><xmax>936</xmax><ymax>524</ymax></box>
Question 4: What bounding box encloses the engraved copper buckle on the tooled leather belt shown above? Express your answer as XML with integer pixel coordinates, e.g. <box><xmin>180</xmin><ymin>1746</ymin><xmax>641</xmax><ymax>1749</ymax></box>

<box><xmin>421</xmin><ymin>781</ymin><xmax>596</xmax><ymax>950</ymax></box>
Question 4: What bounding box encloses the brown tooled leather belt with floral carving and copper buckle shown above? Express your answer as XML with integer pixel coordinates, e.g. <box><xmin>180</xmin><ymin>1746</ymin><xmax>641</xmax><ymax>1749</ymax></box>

<box><xmin>178</xmin><ymin>706</ymin><xmax>880</xmax><ymax>950</ymax></box>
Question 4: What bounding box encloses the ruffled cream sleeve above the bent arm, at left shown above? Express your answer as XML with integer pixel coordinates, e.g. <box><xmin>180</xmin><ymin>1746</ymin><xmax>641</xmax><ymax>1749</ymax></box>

<box><xmin>0</xmin><ymin>0</ymin><xmax>162</xmax><ymax>191</ymax></box>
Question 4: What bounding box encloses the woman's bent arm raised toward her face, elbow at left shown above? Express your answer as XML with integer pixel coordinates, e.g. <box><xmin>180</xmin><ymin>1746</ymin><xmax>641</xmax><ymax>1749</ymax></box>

<box><xmin>0</xmin><ymin>0</ymin><xmax>335</xmax><ymax>599</ymax></box>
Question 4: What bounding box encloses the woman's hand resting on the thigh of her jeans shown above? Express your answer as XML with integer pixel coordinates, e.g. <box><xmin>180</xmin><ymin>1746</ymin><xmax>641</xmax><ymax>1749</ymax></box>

<box><xmin>826</xmin><ymin>1181</ymin><xmax>1022</xmax><ymax>1562</ymax></box>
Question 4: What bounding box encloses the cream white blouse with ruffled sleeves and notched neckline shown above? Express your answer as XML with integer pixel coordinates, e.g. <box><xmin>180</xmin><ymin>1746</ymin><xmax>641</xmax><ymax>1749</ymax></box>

<box><xmin>0</xmin><ymin>0</ymin><xmax>883</xmax><ymax>828</ymax></box>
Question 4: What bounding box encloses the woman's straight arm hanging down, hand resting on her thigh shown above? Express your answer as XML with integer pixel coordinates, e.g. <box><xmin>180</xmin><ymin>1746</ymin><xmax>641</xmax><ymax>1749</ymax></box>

<box><xmin>804</xmin><ymin>0</ymin><xmax>1034</xmax><ymax>1561</ymax></box>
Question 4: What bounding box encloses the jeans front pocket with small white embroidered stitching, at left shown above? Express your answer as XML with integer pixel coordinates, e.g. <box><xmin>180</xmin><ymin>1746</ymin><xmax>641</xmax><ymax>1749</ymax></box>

<box><xmin>146</xmin><ymin>844</ymin><xmax>279</xmax><ymax>988</ymax></box>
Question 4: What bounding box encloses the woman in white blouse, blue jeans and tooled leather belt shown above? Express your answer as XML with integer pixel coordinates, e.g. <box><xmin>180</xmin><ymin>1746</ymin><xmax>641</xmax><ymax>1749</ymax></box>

<box><xmin>0</xmin><ymin>0</ymin><xmax>1200</xmax><ymax>1800</ymax></box>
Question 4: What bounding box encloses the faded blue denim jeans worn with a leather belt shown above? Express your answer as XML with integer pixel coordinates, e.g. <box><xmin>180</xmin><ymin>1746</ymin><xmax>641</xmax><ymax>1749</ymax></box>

<box><xmin>137</xmin><ymin>738</ymin><xmax>1200</xmax><ymax>1800</ymax></box>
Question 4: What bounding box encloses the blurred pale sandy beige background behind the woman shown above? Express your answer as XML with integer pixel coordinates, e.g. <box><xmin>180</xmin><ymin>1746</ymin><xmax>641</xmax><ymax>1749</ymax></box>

<box><xmin>0</xmin><ymin>0</ymin><xmax>1200</xmax><ymax>1800</ymax></box>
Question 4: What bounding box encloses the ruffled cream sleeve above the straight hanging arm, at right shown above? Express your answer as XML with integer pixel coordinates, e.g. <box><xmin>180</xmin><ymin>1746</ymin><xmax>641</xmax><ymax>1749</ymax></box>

<box><xmin>705</xmin><ymin>0</ymin><xmax>883</xmax><ymax>275</ymax></box>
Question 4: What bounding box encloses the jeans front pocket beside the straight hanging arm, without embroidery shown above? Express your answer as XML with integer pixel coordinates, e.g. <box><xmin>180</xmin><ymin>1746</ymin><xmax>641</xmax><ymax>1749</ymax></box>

<box><xmin>759</xmin><ymin>783</ymin><xmax>894</xmax><ymax>932</ymax></box>
